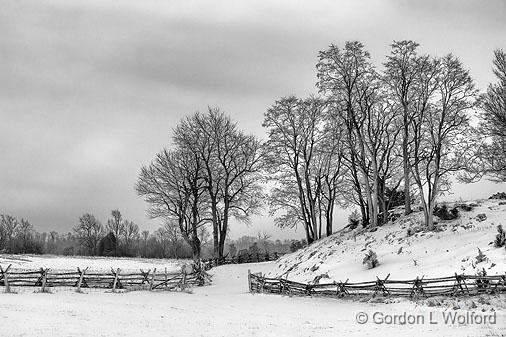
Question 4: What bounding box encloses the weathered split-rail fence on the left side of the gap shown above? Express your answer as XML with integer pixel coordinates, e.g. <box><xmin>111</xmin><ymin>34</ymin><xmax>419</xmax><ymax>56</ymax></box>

<box><xmin>0</xmin><ymin>265</ymin><xmax>211</xmax><ymax>292</ymax></box>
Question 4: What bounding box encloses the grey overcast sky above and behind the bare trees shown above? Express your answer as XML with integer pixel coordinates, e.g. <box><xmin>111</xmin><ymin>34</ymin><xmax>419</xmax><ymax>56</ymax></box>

<box><xmin>0</xmin><ymin>0</ymin><xmax>506</xmax><ymax>238</ymax></box>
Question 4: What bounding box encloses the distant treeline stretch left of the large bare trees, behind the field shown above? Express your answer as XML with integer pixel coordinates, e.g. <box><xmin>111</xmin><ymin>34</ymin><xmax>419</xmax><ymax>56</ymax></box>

<box><xmin>0</xmin><ymin>210</ymin><xmax>195</xmax><ymax>258</ymax></box>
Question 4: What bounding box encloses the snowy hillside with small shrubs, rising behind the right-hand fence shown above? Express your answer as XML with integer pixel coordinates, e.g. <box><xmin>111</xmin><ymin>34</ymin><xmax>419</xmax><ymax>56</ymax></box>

<box><xmin>267</xmin><ymin>200</ymin><xmax>506</xmax><ymax>283</ymax></box>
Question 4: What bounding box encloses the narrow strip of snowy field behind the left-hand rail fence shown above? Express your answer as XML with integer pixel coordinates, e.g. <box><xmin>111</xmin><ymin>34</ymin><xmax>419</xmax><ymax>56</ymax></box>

<box><xmin>0</xmin><ymin>254</ymin><xmax>189</xmax><ymax>271</ymax></box>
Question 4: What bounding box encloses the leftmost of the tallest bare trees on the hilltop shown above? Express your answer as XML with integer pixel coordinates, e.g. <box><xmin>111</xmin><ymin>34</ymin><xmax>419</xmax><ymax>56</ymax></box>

<box><xmin>317</xmin><ymin>41</ymin><xmax>381</xmax><ymax>227</ymax></box>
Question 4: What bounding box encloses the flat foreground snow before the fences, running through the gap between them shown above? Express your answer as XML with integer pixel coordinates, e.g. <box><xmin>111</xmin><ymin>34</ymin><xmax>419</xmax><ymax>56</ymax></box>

<box><xmin>0</xmin><ymin>262</ymin><xmax>506</xmax><ymax>337</ymax></box>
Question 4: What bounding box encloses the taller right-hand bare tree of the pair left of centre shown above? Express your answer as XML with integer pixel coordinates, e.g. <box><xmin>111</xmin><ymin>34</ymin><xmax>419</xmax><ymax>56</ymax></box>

<box><xmin>174</xmin><ymin>108</ymin><xmax>262</xmax><ymax>257</ymax></box>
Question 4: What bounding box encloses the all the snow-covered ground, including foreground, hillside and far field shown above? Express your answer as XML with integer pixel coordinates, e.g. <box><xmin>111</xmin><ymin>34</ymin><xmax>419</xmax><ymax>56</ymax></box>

<box><xmin>0</xmin><ymin>200</ymin><xmax>506</xmax><ymax>337</ymax></box>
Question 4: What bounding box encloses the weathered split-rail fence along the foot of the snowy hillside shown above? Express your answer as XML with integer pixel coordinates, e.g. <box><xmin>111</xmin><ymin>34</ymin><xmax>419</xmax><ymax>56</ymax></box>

<box><xmin>248</xmin><ymin>272</ymin><xmax>506</xmax><ymax>298</ymax></box>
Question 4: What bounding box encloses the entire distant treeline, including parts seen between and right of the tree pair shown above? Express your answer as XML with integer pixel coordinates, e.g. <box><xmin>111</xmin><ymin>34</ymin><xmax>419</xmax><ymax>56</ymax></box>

<box><xmin>0</xmin><ymin>210</ymin><xmax>307</xmax><ymax>258</ymax></box>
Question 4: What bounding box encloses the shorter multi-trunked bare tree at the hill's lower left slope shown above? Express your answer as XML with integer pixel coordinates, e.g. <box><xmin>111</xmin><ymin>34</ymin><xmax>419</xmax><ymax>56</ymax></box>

<box><xmin>263</xmin><ymin>96</ymin><xmax>342</xmax><ymax>243</ymax></box>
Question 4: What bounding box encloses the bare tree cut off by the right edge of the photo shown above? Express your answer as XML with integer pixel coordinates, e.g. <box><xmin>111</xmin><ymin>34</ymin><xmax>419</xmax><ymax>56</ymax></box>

<box><xmin>479</xmin><ymin>49</ymin><xmax>506</xmax><ymax>182</ymax></box>
